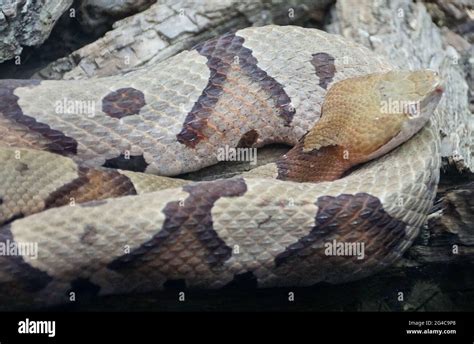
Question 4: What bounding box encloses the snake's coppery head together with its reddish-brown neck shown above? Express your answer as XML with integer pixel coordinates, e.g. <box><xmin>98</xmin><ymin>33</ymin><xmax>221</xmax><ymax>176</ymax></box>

<box><xmin>277</xmin><ymin>70</ymin><xmax>443</xmax><ymax>182</ymax></box>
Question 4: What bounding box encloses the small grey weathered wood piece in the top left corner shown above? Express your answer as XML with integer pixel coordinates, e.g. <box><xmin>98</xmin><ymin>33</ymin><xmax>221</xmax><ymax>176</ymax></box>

<box><xmin>0</xmin><ymin>0</ymin><xmax>73</xmax><ymax>62</ymax></box>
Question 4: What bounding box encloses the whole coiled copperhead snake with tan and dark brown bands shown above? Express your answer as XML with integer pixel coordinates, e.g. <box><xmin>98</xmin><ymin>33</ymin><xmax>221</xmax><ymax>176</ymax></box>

<box><xmin>0</xmin><ymin>25</ymin><xmax>443</xmax><ymax>308</ymax></box>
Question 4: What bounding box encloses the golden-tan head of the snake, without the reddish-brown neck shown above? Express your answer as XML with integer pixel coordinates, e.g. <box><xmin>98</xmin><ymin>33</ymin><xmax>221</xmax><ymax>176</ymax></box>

<box><xmin>303</xmin><ymin>70</ymin><xmax>443</xmax><ymax>166</ymax></box>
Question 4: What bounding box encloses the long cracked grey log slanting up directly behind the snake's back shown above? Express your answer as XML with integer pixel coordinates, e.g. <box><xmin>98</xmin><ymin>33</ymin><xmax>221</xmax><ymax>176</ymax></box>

<box><xmin>35</xmin><ymin>0</ymin><xmax>331</xmax><ymax>79</ymax></box>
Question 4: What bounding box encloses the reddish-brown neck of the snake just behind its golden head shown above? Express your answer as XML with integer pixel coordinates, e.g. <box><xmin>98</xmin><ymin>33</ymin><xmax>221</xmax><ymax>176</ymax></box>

<box><xmin>276</xmin><ymin>142</ymin><xmax>354</xmax><ymax>183</ymax></box>
